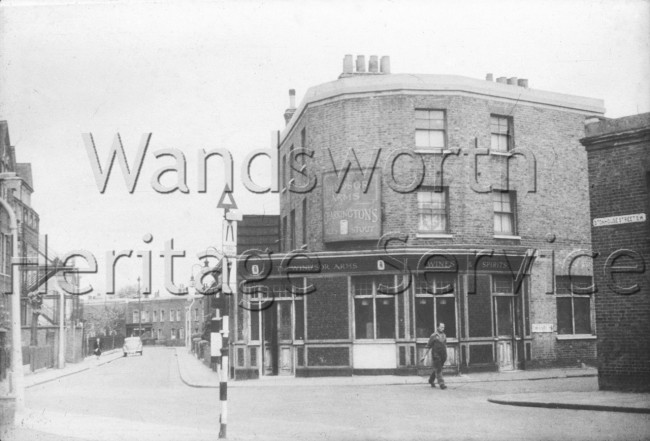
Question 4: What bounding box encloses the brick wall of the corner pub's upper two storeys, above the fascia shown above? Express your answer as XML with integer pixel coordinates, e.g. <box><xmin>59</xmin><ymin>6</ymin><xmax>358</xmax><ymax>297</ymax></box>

<box><xmin>280</xmin><ymin>95</ymin><xmax>590</xmax><ymax>251</ymax></box>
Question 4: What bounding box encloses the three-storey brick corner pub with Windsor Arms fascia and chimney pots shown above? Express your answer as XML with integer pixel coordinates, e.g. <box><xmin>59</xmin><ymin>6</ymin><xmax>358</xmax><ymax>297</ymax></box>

<box><xmin>232</xmin><ymin>56</ymin><xmax>604</xmax><ymax>378</ymax></box>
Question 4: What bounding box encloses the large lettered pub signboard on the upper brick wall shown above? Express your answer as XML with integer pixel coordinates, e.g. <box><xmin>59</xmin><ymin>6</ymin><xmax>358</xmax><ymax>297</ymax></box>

<box><xmin>323</xmin><ymin>169</ymin><xmax>381</xmax><ymax>242</ymax></box>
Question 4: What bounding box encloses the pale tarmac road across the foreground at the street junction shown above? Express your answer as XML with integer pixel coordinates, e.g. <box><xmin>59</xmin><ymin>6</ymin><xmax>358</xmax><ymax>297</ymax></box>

<box><xmin>19</xmin><ymin>348</ymin><xmax>650</xmax><ymax>441</ymax></box>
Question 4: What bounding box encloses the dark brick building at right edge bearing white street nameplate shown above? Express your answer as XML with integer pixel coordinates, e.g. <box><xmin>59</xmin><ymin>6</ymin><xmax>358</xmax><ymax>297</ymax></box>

<box><xmin>582</xmin><ymin>113</ymin><xmax>650</xmax><ymax>391</ymax></box>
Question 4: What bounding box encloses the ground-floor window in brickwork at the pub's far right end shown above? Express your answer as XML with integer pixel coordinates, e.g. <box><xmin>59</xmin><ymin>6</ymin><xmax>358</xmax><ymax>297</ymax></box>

<box><xmin>555</xmin><ymin>276</ymin><xmax>592</xmax><ymax>334</ymax></box>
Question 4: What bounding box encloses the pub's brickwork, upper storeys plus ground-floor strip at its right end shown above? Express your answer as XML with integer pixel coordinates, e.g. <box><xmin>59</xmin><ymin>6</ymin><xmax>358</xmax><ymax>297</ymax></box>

<box><xmin>279</xmin><ymin>76</ymin><xmax>595</xmax><ymax>364</ymax></box>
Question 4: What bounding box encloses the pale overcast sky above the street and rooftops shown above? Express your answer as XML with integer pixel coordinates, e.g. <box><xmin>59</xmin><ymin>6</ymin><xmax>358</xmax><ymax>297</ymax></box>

<box><xmin>0</xmin><ymin>0</ymin><xmax>650</xmax><ymax>292</ymax></box>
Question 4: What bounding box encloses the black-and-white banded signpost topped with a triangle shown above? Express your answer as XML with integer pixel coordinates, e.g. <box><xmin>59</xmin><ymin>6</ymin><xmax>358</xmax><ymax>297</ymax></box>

<box><xmin>217</xmin><ymin>185</ymin><xmax>242</xmax><ymax>439</ymax></box>
